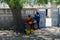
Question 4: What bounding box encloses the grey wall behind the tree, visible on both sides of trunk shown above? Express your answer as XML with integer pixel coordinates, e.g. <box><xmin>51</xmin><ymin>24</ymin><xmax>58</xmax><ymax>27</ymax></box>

<box><xmin>0</xmin><ymin>8</ymin><xmax>36</xmax><ymax>29</ymax></box>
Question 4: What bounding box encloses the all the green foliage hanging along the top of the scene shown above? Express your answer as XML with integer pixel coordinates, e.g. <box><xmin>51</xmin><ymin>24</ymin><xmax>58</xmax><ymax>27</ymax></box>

<box><xmin>3</xmin><ymin>0</ymin><xmax>60</xmax><ymax>9</ymax></box>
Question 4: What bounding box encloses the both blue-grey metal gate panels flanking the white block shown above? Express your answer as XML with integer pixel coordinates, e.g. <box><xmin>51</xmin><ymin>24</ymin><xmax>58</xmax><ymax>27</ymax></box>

<box><xmin>39</xmin><ymin>8</ymin><xmax>59</xmax><ymax>27</ymax></box>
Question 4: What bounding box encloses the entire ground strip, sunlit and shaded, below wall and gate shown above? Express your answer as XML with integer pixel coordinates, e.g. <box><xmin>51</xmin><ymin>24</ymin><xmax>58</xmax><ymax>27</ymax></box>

<box><xmin>0</xmin><ymin>27</ymin><xmax>60</xmax><ymax>40</ymax></box>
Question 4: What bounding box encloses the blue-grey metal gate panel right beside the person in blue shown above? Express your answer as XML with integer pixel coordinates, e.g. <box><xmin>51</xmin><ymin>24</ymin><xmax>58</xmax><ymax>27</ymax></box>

<box><xmin>39</xmin><ymin>8</ymin><xmax>46</xmax><ymax>27</ymax></box>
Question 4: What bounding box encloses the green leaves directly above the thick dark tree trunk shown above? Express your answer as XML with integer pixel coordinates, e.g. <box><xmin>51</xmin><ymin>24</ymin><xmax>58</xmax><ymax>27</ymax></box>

<box><xmin>3</xmin><ymin>0</ymin><xmax>26</xmax><ymax>9</ymax></box>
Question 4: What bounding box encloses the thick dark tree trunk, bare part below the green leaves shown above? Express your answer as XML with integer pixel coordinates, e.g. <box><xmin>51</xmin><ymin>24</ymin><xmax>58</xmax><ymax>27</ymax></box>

<box><xmin>11</xmin><ymin>9</ymin><xmax>24</xmax><ymax>32</ymax></box>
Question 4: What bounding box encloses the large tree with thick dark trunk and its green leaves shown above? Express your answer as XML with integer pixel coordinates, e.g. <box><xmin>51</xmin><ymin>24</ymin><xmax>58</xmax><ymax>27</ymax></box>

<box><xmin>3</xmin><ymin>0</ymin><xmax>26</xmax><ymax>32</ymax></box>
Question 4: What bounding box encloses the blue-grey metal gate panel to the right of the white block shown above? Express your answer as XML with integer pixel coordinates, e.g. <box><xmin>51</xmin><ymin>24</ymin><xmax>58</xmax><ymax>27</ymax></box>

<box><xmin>51</xmin><ymin>8</ymin><xmax>58</xmax><ymax>27</ymax></box>
